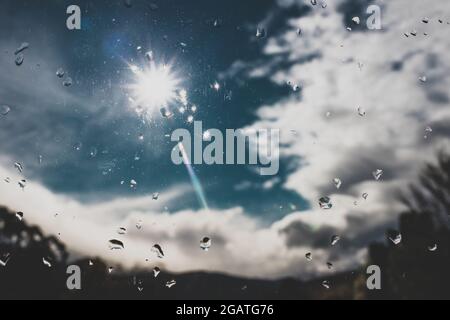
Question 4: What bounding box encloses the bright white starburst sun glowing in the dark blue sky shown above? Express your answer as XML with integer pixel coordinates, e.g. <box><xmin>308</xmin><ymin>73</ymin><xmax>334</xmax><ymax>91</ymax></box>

<box><xmin>128</xmin><ymin>61</ymin><xmax>181</xmax><ymax>112</ymax></box>
